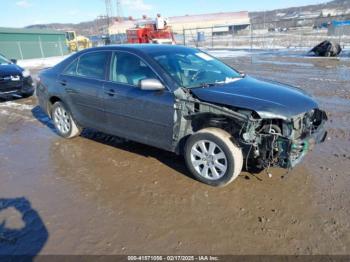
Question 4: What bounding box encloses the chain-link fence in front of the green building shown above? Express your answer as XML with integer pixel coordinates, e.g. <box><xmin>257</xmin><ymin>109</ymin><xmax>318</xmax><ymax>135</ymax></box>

<box><xmin>0</xmin><ymin>41</ymin><xmax>68</xmax><ymax>60</ymax></box>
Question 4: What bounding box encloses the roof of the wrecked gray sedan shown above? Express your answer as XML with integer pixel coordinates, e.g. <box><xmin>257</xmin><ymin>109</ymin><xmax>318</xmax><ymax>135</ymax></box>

<box><xmin>80</xmin><ymin>44</ymin><xmax>195</xmax><ymax>54</ymax></box>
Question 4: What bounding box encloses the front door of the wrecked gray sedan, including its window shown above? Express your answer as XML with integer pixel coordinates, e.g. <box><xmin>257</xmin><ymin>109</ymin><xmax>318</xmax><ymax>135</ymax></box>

<box><xmin>104</xmin><ymin>51</ymin><xmax>175</xmax><ymax>150</ymax></box>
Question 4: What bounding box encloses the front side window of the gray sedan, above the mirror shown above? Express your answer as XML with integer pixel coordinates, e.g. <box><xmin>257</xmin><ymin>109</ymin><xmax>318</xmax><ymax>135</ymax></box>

<box><xmin>110</xmin><ymin>53</ymin><xmax>158</xmax><ymax>86</ymax></box>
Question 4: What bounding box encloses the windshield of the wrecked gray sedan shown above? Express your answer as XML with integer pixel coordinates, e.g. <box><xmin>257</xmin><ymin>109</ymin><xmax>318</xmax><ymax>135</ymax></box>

<box><xmin>151</xmin><ymin>49</ymin><xmax>242</xmax><ymax>88</ymax></box>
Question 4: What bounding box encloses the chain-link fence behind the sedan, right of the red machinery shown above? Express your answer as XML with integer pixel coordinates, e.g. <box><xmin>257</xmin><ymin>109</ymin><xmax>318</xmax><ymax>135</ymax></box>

<box><xmin>180</xmin><ymin>24</ymin><xmax>350</xmax><ymax>49</ymax></box>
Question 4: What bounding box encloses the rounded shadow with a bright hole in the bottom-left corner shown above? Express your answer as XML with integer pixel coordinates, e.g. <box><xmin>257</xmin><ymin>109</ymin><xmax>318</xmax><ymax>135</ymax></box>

<box><xmin>0</xmin><ymin>197</ymin><xmax>49</xmax><ymax>261</ymax></box>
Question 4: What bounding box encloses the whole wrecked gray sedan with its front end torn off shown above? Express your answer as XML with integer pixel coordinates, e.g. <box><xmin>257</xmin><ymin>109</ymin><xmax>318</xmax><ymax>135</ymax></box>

<box><xmin>37</xmin><ymin>45</ymin><xmax>327</xmax><ymax>186</ymax></box>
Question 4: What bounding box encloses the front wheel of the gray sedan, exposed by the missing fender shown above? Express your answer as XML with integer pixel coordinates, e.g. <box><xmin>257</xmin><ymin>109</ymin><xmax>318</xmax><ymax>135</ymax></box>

<box><xmin>185</xmin><ymin>128</ymin><xmax>243</xmax><ymax>187</ymax></box>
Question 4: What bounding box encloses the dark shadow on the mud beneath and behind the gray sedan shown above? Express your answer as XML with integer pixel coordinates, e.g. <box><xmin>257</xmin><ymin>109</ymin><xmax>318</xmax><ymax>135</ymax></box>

<box><xmin>32</xmin><ymin>106</ymin><xmax>194</xmax><ymax>179</ymax></box>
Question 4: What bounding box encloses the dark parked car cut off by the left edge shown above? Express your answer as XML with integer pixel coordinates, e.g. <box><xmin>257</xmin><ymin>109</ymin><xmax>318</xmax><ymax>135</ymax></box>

<box><xmin>0</xmin><ymin>54</ymin><xmax>34</xmax><ymax>97</ymax></box>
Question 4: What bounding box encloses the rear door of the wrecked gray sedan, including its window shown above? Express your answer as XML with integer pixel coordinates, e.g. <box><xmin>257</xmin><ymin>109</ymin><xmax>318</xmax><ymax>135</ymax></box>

<box><xmin>59</xmin><ymin>51</ymin><xmax>111</xmax><ymax>131</ymax></box>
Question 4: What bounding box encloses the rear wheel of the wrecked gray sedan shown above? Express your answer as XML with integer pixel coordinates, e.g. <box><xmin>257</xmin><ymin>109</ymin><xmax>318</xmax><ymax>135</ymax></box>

<box><xmin>51</xmin><ymin>102</ymin><xmax>81</xmax><ymax>138</ymax></box>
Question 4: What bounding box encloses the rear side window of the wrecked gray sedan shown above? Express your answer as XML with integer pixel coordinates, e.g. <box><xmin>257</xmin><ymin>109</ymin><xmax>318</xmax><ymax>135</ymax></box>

<box><xmin>77</xmin><ymin>52</ymin><xmax>108</xmax><ymax>80</ymax></box>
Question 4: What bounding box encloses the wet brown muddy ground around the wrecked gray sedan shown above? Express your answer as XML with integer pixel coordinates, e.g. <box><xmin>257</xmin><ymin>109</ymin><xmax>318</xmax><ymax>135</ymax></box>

<box><xmin>0</xmin><ymin>50</ymin><xmax>350</xmax><ymax>254</ymax></box>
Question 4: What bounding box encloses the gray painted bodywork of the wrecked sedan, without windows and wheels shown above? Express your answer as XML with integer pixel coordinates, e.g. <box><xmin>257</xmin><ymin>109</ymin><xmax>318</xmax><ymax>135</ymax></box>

<box><xmin>37</xmin><ymin>45</ymin><xmax>326</xmax><ymax>168</ymax></box>
